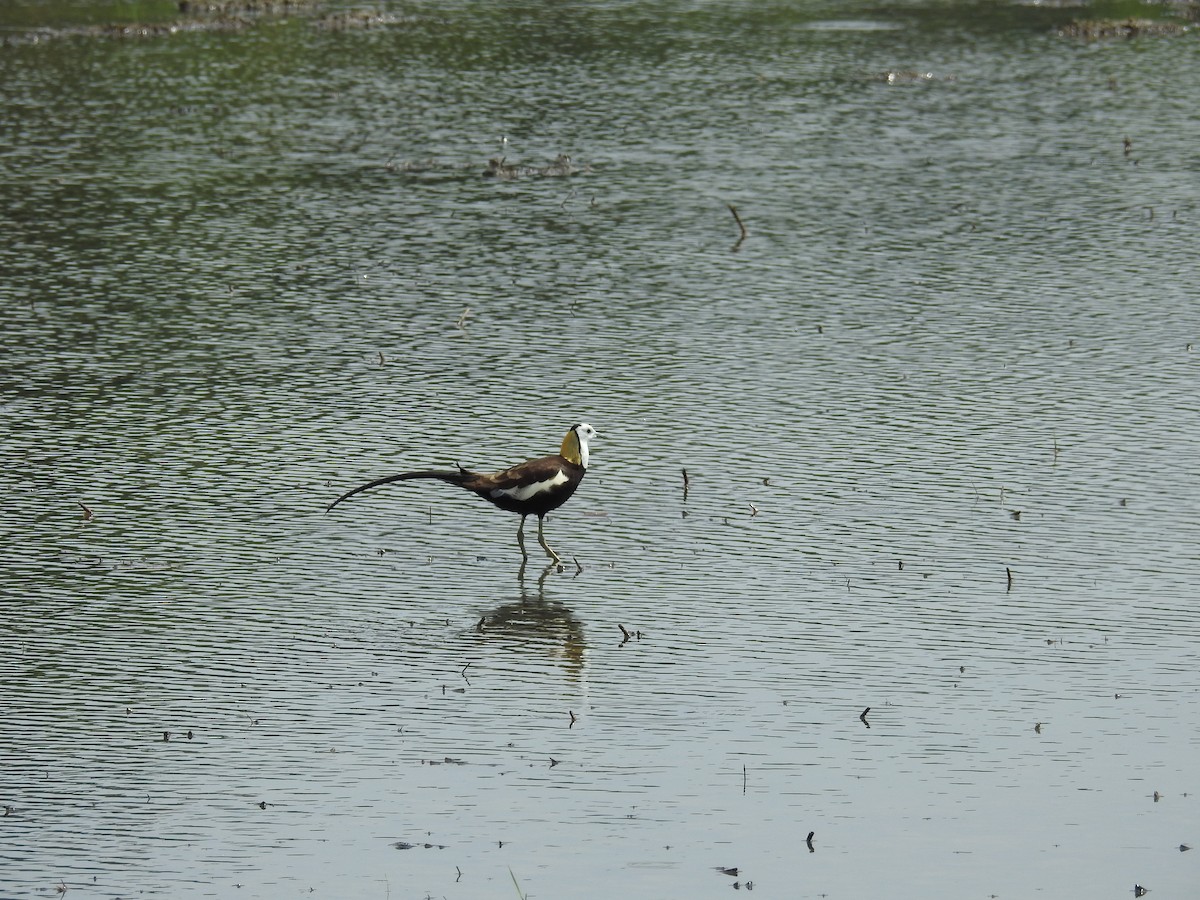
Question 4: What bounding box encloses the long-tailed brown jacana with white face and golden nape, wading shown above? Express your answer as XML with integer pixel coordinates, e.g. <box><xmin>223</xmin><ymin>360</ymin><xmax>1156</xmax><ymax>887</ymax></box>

<box><xmin>325</xmin><ymin>422</ymin><xmax>596</xmax><ymax>563</ymax></box>
